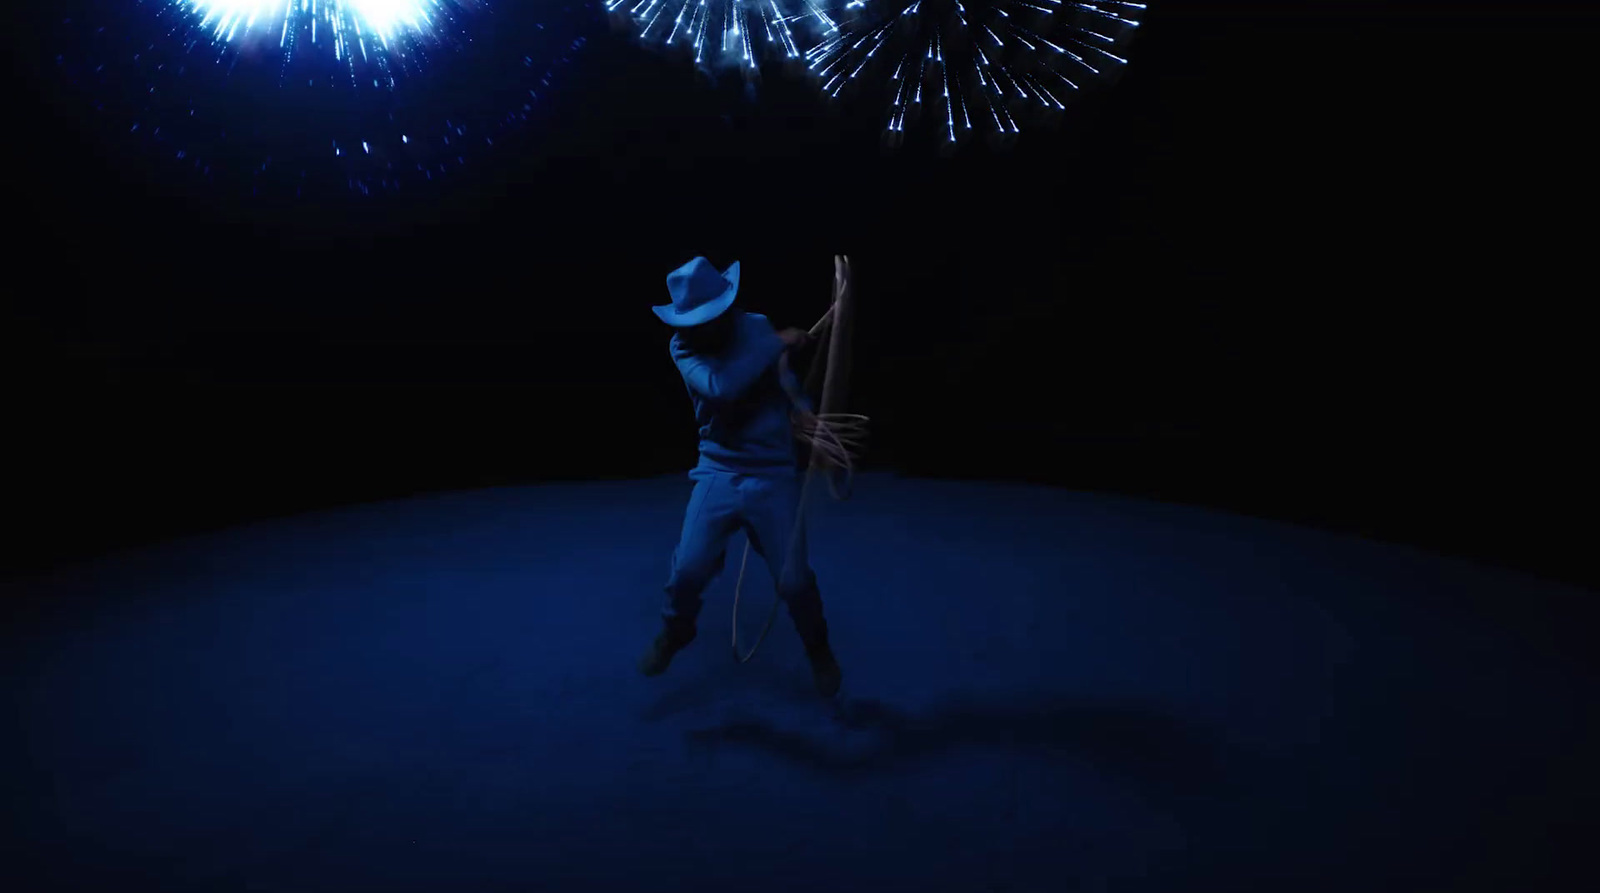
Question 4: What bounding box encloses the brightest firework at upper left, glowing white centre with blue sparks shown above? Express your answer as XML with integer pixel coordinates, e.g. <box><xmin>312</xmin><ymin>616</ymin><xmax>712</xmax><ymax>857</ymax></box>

<box><xmin>56</xmin><ymin>0</ymin><xmax>594</xmax><ymax>195</ymax></box>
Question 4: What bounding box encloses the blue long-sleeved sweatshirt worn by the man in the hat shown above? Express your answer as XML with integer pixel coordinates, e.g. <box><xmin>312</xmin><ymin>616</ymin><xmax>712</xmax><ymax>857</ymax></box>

<box><xmin>672</xmin><ymin>310</ymin><xmax>811</xmax><ymax>475</ymax></box>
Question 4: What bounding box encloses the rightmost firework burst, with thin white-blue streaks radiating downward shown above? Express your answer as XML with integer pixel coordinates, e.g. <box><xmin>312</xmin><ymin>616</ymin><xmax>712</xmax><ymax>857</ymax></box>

<box><xmin>805</xmin><ymin>0</ymin><xmax>1146</xmax><ymax>142</ymax></box>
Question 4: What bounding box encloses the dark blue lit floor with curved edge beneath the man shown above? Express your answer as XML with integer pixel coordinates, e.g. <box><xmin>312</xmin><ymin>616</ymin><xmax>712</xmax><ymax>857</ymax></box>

<box><xmin>3</xmin><ymin>477</ymin><xmax>1600</xmax><ymax>893</ymax></box>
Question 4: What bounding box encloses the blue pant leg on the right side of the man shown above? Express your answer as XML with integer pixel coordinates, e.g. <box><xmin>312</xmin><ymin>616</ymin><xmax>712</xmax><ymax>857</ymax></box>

<box><xmin>741</xmin><ymin>475</ymin><xmax>827</xmax><ymax>647</ymax></box>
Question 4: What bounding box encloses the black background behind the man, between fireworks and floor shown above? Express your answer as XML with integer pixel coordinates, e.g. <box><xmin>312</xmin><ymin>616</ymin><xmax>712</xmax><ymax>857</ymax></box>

<box><xmin>3</xmin><ymin>0</ymin><xmax>1600</xmax><ymax>584</ymax></box>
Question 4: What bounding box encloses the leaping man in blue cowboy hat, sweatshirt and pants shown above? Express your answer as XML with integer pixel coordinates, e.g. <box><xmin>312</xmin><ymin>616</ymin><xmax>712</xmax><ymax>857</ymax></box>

<box><xmin>638</xmin><ymin>258</ymin><xmax>840</xmax><ymax>698</ymax></box>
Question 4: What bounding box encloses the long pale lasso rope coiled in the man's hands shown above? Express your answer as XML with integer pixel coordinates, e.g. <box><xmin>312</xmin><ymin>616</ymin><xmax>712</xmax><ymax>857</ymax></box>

<box><xmin>733</xmin><ymin>258</ymin><xmax>869</xmax><ymax>664</ymax></box>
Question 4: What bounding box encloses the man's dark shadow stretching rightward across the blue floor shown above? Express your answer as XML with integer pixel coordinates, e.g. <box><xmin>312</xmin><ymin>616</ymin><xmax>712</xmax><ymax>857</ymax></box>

<box><xmin>688</xmin><ymin>699</ymin><xmax>1224</xmax><ymax>800</ymax></box>
